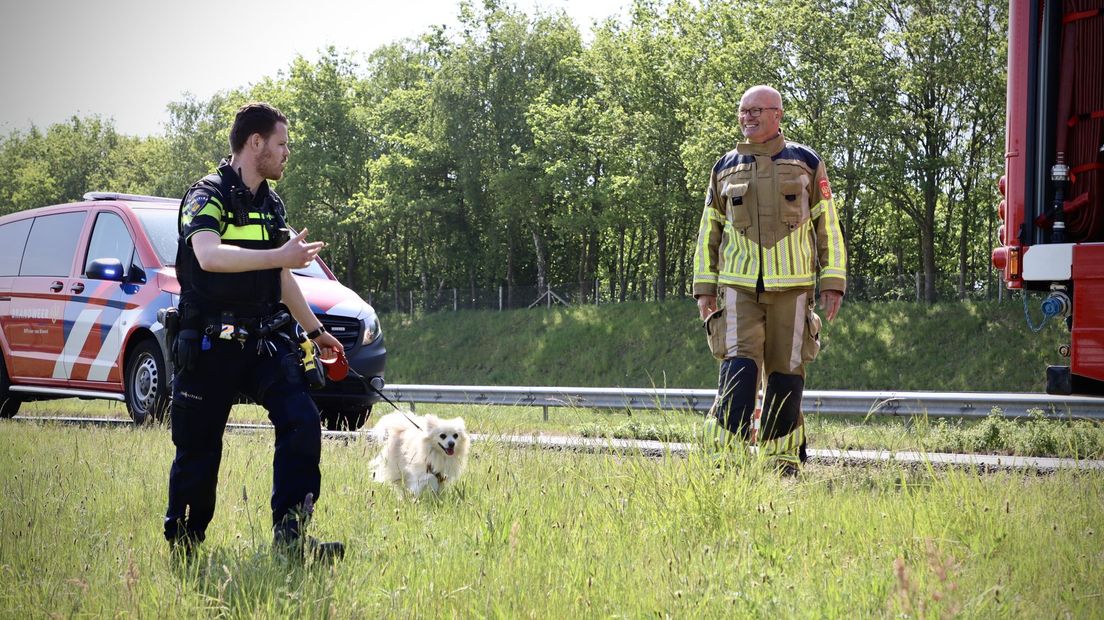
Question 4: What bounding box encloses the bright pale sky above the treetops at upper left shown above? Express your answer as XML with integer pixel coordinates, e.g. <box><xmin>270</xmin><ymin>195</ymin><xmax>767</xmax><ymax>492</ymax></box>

<box><xmin>0</xmin><ymin>0</ymin><xmax>631</xmax><ymax>136</ymax></box>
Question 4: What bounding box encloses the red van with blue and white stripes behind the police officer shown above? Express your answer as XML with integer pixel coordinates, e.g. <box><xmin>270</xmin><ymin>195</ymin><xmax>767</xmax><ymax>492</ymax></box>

<box><xmin>0</xmin><ymin>193</ymin><xmax>386</xmax><ymax>429</ymax></box>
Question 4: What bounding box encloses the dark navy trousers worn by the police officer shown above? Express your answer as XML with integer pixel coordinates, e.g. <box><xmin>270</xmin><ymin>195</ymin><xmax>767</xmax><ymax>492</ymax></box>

<box><xmin>164</xmin><ymin>336</ymin><xmax>322</xmax><ymax>541</ymax></box>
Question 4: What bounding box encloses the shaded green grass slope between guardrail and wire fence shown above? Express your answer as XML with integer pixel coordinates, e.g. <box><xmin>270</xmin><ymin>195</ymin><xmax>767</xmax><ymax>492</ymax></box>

<box><xmin>382</xmin><ymin>297</ymin><xmax>1069</xmax><ymax>392</ymax></box>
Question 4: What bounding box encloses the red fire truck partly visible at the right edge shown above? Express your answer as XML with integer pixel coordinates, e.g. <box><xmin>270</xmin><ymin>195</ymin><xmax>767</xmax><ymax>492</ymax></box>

<box><xmin>992</xmin><ymin>0</ymin><xmax>1104</xmax><ymax>395</ymax></box>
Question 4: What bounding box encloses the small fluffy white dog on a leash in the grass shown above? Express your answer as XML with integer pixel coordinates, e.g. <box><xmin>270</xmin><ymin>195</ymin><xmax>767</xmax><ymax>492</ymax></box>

<box><xmin>372</xmin><ymin>411</ymin><xmax>470</xmax><ymax>496</ymax></box>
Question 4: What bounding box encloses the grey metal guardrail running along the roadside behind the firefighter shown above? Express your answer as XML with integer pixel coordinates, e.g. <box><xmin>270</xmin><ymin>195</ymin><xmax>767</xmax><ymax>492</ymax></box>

<box><xmin>383</xmin><ymin>384</ymin><xmax>1104</xmax><ymax>420</ymax></box>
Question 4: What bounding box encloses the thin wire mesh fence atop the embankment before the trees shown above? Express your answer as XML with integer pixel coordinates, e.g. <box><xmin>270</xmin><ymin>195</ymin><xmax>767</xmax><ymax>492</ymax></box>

<box><xmin>362</xmin><ymin>271</ymin><xmax>1009</xmax><ymax>313</ymax></box>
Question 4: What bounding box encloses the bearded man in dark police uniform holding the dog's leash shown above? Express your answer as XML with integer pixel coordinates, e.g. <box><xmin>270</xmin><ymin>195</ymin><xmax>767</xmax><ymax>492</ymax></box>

<box><xmin>164</xmin><ymin>103</ymin><xmax>344</xmax><ymax>558</ymax></box>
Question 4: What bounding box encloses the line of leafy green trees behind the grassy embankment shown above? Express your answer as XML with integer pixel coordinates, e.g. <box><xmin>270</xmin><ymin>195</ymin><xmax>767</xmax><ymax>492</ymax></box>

<box><xmin>0</xmin><ymin>0</ymin><xmax>1007</xmax><ymax>301</ymax></box>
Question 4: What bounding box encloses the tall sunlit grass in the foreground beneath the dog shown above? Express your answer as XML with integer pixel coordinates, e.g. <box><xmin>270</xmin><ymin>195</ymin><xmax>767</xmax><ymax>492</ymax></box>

<box><xmin>0</xmin><ymin>421</ymin><xmax>1104</xmax><ymax>618</ymax></box>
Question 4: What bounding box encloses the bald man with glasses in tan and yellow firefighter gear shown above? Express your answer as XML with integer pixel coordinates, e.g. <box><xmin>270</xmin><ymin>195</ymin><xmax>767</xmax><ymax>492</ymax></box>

<box><xmin>693</xmin><ymin>86</ymin><xmax>847</xmax><ymax>473</ymax></box>
